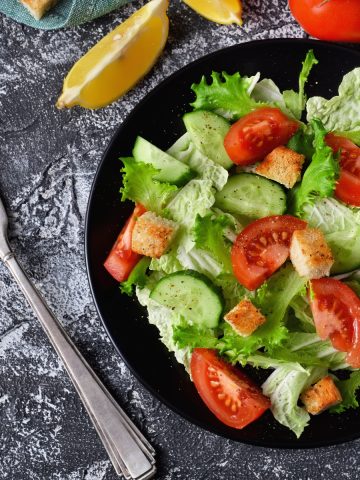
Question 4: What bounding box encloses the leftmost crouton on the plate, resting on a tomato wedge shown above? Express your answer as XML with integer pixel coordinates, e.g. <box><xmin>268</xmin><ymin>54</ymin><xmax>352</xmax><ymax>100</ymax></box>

<box><xmin>131</xmin><ymin>212</ymin><xmax>177</xmax><ymax>258</ymax></box>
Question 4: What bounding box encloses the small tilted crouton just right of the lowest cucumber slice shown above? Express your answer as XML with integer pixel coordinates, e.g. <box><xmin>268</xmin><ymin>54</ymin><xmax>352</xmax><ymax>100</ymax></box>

<box><xmin>224</xmin><ymin>299</ymin><xmax>266</xmax><ymax>337</ymax></box>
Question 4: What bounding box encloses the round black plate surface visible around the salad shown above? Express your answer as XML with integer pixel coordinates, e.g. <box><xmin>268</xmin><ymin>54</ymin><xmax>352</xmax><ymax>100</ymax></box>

<box><xmin>86</xmin><ymin>39</ymin><xmax>360</xmax><ymax>448</ymax></box>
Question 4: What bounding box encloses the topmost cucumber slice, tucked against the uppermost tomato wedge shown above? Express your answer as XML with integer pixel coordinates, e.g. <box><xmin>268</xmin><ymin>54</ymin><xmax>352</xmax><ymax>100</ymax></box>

<box><xmin>183</xmin><ymin>110</ymin><xmax>234</xmax><ymax>169</ymax></box>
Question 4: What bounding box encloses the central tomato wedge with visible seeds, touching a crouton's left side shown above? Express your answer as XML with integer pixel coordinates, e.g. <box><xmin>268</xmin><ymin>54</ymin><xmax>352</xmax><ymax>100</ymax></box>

<box><xmin>231</xmin><ymin>215</ymin><xmax>306</xmax><ymax>290</ymax></box>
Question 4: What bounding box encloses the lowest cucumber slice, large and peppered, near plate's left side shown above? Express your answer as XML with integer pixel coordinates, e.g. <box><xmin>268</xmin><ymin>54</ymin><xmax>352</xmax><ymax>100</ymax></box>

<box><xmin>150</xmin><ymin>270</ymin><xmax>224</xmax><ymax>328</ymax></box>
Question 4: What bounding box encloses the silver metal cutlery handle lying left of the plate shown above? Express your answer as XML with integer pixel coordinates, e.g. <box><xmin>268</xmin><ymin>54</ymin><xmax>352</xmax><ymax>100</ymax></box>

<box><xmin>2</xmin><ymin>252</ymin><xmax>155</xmax><ymax>479</ymax></box>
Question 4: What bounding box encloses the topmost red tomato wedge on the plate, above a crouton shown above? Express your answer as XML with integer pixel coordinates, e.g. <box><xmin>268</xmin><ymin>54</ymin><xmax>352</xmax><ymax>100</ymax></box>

<box><xmin>224</xmin><ymin>107</ymin><xmax>299</xmax><ymax>165</ymax></box>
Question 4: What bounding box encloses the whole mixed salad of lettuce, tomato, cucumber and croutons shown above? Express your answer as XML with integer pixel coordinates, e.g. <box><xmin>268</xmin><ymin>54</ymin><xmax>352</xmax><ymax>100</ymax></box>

<box><xmin>104</xmin><ymin>50</ymin><xmax>360</xmax><ymax>437</ymax></box>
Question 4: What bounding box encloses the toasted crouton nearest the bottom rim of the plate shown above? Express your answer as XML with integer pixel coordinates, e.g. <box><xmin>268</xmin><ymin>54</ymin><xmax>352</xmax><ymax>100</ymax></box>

<box><xmin>300</xmin><ymin>376</ymin><xmax>342</xmax><ymax>415</ymax></box>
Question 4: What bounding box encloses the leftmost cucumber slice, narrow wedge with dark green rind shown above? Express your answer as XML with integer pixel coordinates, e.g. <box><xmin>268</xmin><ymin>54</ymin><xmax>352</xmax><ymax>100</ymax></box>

<box><xmin>133</xmin><ymin>137</ymin><xmax>194</xmax><ymax>187</ymax></box>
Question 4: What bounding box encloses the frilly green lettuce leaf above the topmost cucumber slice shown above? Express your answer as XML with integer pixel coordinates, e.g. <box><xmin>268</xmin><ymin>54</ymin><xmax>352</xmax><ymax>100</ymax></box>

<box><xmin>191</xmin><ymin>72</ymin><xmax>264</xmax><ymax>120</ymax></box>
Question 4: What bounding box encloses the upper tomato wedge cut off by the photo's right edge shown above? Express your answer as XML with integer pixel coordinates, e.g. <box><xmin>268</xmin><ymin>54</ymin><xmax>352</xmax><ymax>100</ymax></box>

<box><xmin>325</xmin><ymin>133</ymin><xmax>360</xmax><ymax>207</ymax></box>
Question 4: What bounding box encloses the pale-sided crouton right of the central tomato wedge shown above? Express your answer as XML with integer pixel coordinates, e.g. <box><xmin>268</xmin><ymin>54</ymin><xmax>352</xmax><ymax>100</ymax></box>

<box><xmin>290</xmin><ymin>228</ymin><xmax>334</xmax><ymax>279</ymax></box>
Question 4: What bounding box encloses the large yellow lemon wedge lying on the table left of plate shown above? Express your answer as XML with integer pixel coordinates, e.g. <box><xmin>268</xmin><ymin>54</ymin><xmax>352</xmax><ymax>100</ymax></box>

<box><xmin>56</xmin><ymin>0</ymin><xmax>169</xmax><ymax>108</ymax></box>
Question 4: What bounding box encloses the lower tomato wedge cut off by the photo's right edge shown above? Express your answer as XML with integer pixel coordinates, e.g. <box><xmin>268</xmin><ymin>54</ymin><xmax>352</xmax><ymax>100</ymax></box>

<box><xmin>310</xmin><ymin>278</ymin><xmax>360</xmax><ymax>368</ymax></box>
